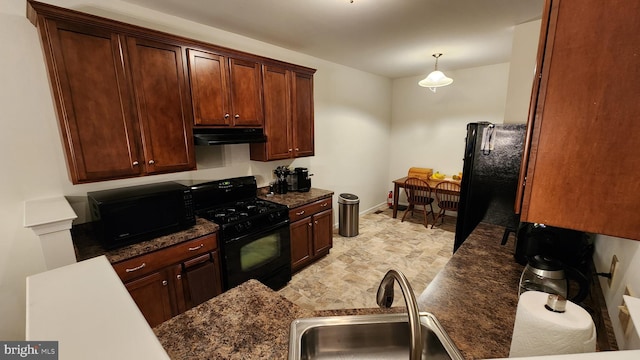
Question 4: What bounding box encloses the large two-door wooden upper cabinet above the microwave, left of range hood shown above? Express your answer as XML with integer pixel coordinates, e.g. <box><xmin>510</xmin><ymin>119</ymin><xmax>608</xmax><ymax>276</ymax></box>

<box><xmin>27</xmin><ymin>2</ymin><xmax>195</xmax><ymax>184</ymax></box>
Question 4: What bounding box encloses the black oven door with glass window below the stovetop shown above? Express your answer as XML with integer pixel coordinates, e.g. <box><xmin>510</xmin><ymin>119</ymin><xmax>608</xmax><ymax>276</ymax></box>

<box><xmin>222</xmin><ymin>220</ymin><xmax>291</xmax><ymax>290</ymax></box>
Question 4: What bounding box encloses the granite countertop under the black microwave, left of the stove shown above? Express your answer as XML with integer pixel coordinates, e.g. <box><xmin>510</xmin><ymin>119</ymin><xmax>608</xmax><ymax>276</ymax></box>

<box><xmin>71</xmin><ymin>218</ymin><xmax>218</xmax><ymax>264</ymax></box>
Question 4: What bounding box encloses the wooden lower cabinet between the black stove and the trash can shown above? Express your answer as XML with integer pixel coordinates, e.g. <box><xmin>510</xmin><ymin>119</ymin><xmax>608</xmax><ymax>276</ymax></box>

<box><xmin>289</xmin><ymin>198</ymin><xmax>333</xmax><ymax>272</ymax></box>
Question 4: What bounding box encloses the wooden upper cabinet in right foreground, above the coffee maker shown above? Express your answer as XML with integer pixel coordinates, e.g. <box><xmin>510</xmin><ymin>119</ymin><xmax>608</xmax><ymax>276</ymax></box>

<box><xmin>516</xmin><ymin>0</ymin><xmax>640</xmax><ymax>240</ymax></box>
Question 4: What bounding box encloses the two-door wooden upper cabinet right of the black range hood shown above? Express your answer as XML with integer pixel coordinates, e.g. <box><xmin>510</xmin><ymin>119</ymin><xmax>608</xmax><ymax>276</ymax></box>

<box><xmin>251</xmin><ymin>65</ymin><xmax>314</xmax><ymax>161</ymax></box>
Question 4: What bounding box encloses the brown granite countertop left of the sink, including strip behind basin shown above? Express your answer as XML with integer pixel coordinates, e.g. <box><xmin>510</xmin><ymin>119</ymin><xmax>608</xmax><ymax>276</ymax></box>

<box><xmin>153</xmin><ymin>280</ymin><xmax>404</xmax><ymax>360</ymax></box>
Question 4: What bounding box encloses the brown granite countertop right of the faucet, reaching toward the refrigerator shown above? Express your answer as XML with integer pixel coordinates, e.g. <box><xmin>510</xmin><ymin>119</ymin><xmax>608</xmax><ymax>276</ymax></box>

<box><xmin>418</xmin><ymin>223</ymin><xmax>617</xmax><ymax>359</ymax></box>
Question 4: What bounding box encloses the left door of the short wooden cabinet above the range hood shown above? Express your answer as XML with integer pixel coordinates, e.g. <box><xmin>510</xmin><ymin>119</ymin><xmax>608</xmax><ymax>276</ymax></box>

<box><xmin>187</xmin><ymin>49</ymin><xmax>231</xmax><ymax>126</ymax></box>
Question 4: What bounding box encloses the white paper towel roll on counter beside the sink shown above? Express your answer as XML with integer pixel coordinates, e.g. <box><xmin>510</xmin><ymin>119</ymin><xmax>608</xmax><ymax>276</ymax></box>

<box><xmin>509</xmin><ymin>291</ymin><xmax>596</xmax><ymax>357</ymax></box>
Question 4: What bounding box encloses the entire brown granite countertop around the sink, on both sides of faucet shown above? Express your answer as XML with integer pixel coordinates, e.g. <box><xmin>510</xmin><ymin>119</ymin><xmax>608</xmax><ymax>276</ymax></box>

<box><xmin>154</xmin><ymin>224</ymin><xmax>616</xmax><ymax>360</ymax></box>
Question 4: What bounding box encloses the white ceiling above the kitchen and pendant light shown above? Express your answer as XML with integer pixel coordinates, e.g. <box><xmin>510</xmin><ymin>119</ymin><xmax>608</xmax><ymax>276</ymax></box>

<box><xmin>124</xmin><ymin>0</ymin><xmax>544</xmax><ymax>79</ymax></box>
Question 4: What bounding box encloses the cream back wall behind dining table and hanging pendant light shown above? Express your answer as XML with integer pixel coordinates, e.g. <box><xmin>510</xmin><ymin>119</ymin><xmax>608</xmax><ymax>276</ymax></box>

<box><xmin>388</xmin><ymin>63</ymin><xmax>509</xmax><ymax>183</ymax></box>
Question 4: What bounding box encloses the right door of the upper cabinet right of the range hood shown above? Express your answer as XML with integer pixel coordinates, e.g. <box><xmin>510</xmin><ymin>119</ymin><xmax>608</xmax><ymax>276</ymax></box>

<box><xmin>292</xmin><ymin>72</ymin><xmax>314</xmax><ymax>157</ymax></box>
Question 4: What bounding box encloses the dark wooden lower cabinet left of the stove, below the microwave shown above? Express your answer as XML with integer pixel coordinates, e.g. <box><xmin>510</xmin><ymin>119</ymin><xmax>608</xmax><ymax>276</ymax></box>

<box><xmin>113</xmin><ymin>235</ymin><xmax>222</xmax><ymax>327</ymax></box>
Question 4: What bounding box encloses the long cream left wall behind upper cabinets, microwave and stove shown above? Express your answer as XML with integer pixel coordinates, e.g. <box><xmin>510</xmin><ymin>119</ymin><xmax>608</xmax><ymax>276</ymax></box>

<box><xmin>0</xmin><ymin>0</ymin><xmax>391</xmax><ymax>340</ymax></box>
